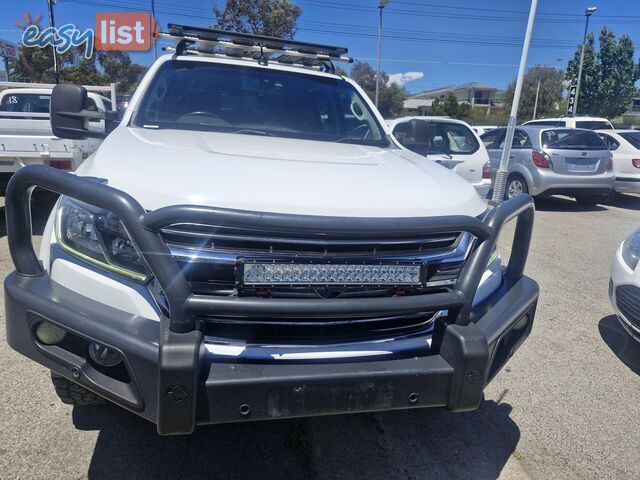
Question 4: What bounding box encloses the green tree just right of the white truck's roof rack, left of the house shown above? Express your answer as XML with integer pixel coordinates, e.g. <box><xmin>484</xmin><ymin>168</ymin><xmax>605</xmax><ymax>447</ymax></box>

<box><xmin>349</xmin><ymin>61</ymin><xmax>409</xmax><ymax>118</ymax></box>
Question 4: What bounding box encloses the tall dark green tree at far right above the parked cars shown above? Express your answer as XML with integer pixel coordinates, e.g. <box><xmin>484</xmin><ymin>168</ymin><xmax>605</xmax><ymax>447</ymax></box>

<box><xmin>565</xmin><ymin>27</ymin><xmax>640</xmax><ymax>118</ymax></box>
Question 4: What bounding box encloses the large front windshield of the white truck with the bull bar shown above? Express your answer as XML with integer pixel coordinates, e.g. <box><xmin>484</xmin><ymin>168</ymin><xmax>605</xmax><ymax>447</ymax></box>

<box><xmin>133</xmin><ymin>61</ymin><xmax>389</xmax><ymax>146</ymax></box>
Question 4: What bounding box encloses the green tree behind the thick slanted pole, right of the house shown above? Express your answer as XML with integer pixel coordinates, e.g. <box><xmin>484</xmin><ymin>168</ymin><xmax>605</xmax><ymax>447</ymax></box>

<box><xmin>503</xmin><ymin>65</ymin><xmax>564</xmax><ymax>122</ymax></box>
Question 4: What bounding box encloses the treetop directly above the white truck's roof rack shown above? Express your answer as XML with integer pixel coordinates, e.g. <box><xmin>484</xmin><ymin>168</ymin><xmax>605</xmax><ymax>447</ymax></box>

<box><xmin>213</xmin><ymin>0</ymin><xmax>302</xmax><ymax>39</ymax></box>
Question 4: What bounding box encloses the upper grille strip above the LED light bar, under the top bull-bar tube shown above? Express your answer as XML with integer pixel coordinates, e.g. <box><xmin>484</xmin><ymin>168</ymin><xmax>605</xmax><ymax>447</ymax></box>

<box><xmin>162</xmin><ymin>224</ymin><xmax>460</xmax><ymax>256</ymax></box>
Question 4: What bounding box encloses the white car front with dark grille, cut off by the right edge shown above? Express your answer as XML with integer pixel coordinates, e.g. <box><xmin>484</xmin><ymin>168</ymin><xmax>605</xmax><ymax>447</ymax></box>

<box><xmin>609</xmin><ymin>228</ymin><xmax>640</xmax><ymax>341</ymax></box>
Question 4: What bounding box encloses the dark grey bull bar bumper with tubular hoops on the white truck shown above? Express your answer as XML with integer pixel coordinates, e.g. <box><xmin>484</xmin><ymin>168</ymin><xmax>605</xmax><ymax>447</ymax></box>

<box><xmin>5</xmin><ymin>166</ymin><xmax>538</xmax><ymax>434</ymax></box>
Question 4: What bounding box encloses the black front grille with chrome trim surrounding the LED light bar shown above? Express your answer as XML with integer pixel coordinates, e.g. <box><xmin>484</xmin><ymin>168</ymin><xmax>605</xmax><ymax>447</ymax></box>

<box><xmin>161</xmin><ymin>224</ymin><xmax>467</xmax><ymax>344</ymax></box>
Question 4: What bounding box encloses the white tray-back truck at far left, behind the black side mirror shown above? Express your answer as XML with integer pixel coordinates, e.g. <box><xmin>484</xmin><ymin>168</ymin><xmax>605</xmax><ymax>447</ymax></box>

<box><xmin>0</xmin><ymin>82</ymin><xmax>115</xmax><ymax>192</ymax></box>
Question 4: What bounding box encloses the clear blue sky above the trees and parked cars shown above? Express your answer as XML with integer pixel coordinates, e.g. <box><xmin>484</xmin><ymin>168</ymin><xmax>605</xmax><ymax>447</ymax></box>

<box><xmin>0</xmin><ymin>0</ymin><xmax>640</xmax><ymax>92</ymax></box>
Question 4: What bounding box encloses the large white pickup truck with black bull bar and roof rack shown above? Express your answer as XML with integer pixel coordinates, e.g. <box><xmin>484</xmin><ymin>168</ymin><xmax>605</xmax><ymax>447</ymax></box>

<box><xmin>5</xmin><ymin>24</ymin><xmax>538</xmax><ymax>434</ymax></box>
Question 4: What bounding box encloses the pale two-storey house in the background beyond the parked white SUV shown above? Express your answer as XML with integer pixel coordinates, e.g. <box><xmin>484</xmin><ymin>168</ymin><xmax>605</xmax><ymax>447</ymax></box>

<box><xmin>404</xmin><ymin>82</ymin><xmax>498</xmax><ymax>114</ymax></box>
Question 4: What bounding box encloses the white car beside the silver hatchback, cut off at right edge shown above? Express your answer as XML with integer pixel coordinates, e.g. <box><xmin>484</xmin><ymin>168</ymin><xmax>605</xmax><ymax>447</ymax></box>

<box><xmin>598</xmin><ymin>130</ymin><xmax>640</xmax><ymax>193</ymax></box>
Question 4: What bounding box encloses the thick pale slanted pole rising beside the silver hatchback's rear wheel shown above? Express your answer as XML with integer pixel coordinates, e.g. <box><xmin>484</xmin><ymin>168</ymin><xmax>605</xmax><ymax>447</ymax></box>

<box><xmin>491</xmin><ymin>0</ymin><xmax>538</xmax><ymax>203</ymax></box>
